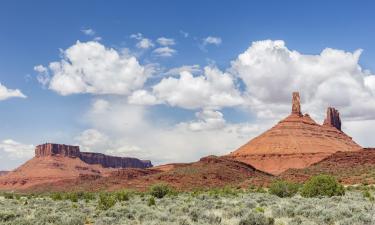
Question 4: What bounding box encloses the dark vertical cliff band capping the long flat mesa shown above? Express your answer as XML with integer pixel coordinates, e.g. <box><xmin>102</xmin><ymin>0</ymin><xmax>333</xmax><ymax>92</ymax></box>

<box><xmin>35</xmin><ymin>143</ymin><xmax>152</xmax><ymax>168</ymax></box>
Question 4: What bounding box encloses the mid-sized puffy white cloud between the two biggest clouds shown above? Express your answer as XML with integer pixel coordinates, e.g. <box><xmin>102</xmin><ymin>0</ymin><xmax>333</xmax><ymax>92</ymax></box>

<box><xmin>153</xmin><ymin>67</ymin><xmax>243</xmax><ymax>109</ymax></box>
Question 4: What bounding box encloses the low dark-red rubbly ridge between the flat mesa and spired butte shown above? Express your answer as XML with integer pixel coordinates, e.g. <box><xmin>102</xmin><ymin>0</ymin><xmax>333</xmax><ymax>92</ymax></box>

<box><xmin>18</xmin><ymin>156</ymin><xmax>273</xmax><ymax>192</ymax></box>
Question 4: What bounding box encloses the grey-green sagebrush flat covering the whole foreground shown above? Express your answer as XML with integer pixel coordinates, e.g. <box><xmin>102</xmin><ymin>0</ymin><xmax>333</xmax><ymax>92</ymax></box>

<box><xmin>0</xmin><ymin>188</ymin><xmax>375</xmax><ymax>225</ymax></box>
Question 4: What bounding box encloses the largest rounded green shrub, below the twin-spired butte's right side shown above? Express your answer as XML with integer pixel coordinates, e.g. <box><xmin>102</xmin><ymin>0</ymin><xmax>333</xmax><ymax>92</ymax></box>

<box><xmin>301</xmin><ymin>175</ymin><xmax>345</xmax><ymax>197</ymax></box>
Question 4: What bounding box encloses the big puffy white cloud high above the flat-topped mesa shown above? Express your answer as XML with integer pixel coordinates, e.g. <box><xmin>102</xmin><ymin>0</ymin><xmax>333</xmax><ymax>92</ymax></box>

<box><xmin>36</xmin><ymin>41</ymin><xmax>151</xmax><ymax>95</ymax></box>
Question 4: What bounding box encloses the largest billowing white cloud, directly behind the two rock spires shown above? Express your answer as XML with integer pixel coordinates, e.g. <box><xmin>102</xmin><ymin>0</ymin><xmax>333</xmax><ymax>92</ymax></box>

<box><xmin>231</xmin><ymin>40</ymin><xmax>375</xmax><ymax>119</ymax></box>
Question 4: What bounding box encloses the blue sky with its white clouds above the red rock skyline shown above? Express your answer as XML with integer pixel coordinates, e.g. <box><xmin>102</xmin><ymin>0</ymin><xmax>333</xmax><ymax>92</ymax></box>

<box><xmin>0</xmin><ymin>1</ymin><xmax>375</xmax><ymax>169</ymax></box>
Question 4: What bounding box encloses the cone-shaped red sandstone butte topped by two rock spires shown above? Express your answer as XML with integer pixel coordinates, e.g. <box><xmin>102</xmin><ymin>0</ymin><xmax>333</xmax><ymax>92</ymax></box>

<box><xmin>227</xmin><ymin>92</ymin><xmax>362</xmax><ymax>175</ymax></box>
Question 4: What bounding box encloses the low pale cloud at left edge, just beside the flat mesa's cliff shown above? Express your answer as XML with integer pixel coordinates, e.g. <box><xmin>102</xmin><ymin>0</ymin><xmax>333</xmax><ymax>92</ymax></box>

<box><xmin>0</xmin><ymin>139</ymin><xmax>34</xmax><ymax>159</ymax></box>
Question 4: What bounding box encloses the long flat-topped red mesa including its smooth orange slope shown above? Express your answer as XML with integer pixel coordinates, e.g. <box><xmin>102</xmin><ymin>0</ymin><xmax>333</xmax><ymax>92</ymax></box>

<box><xmin>0</xmin><ymin>143</ymin><xmax>152</xmax><ymax>190</ymax></box>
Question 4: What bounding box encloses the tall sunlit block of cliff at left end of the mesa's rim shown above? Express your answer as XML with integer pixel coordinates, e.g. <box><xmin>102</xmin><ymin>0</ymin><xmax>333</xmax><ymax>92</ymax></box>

<box><xmin>35</xmin><ymin>143</ymin><xmax>80</xmax><ymax>157</ymax></box>
